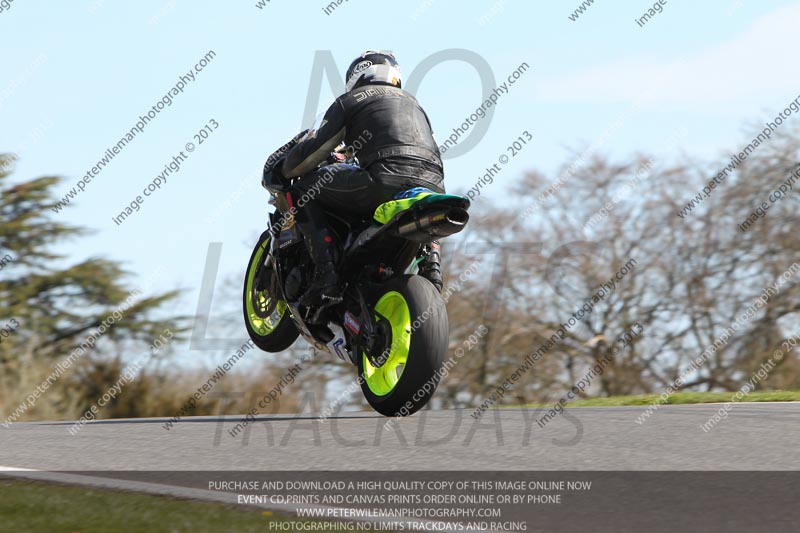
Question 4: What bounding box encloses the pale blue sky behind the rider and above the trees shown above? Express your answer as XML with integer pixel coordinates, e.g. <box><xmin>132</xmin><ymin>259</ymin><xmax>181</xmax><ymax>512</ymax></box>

<box><xmin>0</xmin><ymin>0</ymin><xmax>800</xmax><ymax>366</ymax></box>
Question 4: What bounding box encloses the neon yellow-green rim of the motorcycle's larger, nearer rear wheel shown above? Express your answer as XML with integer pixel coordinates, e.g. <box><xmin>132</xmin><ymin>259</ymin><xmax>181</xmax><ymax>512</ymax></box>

<box><xmin>361</xmin><ymin>291</ymin><xmax>411</xmax><ymax>396</ymax></box>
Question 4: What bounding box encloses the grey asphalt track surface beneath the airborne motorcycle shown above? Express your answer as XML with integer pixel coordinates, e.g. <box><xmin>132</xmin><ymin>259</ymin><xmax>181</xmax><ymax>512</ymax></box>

<box><xmin>0</xmin><ymin>403</ymin><xmax>800</xmax><ymax>531</ymax></box>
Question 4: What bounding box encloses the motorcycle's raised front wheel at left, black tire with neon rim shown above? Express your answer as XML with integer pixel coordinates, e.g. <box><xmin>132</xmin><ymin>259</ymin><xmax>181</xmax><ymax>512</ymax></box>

<box><xmin>242</xmin><ymin>231</ymin><xmax>300</xmax><ymax>353</ymax></box>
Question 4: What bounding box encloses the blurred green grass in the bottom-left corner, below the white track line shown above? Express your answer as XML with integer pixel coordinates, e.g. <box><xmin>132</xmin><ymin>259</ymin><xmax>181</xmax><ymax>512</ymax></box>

<box><xmin>0</xmin><ymin>479</ymin><xmax>332</xmax><ymax>533</ymax></box>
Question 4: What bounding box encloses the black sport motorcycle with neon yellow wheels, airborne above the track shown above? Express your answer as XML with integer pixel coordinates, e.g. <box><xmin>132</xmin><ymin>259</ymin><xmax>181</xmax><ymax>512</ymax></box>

<box><xmin>243</xmin><ymin>129</ymin><xmax>470</xmax><ymax>416</ymax></box>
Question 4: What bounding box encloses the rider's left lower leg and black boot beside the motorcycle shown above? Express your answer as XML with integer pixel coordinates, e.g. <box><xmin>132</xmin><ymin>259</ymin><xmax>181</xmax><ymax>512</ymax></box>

<box><xmin>297</xmin><ymin>202</ymin><xmax>341</xmax><ymax>306</ymax></box>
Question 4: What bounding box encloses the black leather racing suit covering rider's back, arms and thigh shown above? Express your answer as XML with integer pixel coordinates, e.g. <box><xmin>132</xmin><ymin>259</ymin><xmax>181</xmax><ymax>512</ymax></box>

<box><xmin>282</xmin><ymin>85</ymin><xmax>444</xmax><ymax>218</ymax></box>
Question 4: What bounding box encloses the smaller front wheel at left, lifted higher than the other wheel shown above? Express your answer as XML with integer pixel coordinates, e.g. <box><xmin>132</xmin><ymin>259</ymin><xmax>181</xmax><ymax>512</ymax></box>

<box><xmin>242</xmin><ymin>231</ymin><xmax>299</xmax><ymax>352</ymax></box>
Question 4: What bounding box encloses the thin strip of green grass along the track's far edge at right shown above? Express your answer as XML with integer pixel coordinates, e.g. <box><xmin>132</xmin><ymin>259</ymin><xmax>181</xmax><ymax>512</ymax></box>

<box><xmin>526</xmin><ymin>391</ymin><xmax>800</xmax><ymax>407</ymax></box>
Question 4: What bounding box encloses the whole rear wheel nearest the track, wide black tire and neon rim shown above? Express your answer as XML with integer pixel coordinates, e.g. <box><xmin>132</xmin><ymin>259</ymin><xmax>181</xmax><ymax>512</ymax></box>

<box><xmin>358</xmin><ymin>275</ymin><xmax>449</xmax><ymax>416</ymax></box>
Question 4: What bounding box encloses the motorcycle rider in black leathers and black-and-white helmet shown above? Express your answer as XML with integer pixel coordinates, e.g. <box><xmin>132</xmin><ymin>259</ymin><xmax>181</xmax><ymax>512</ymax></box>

<box><xmin>265</xmin><ymin>51</ymin><xmax>445</xmax><ymax>305</ymax></box>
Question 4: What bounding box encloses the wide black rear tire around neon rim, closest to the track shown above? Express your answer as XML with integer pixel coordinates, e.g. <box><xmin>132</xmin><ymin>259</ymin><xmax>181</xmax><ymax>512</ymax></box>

<box><xmin>357</xmin><ymin>275</ymin><xmax>450</xmax><ymax>416</ymax></box>
